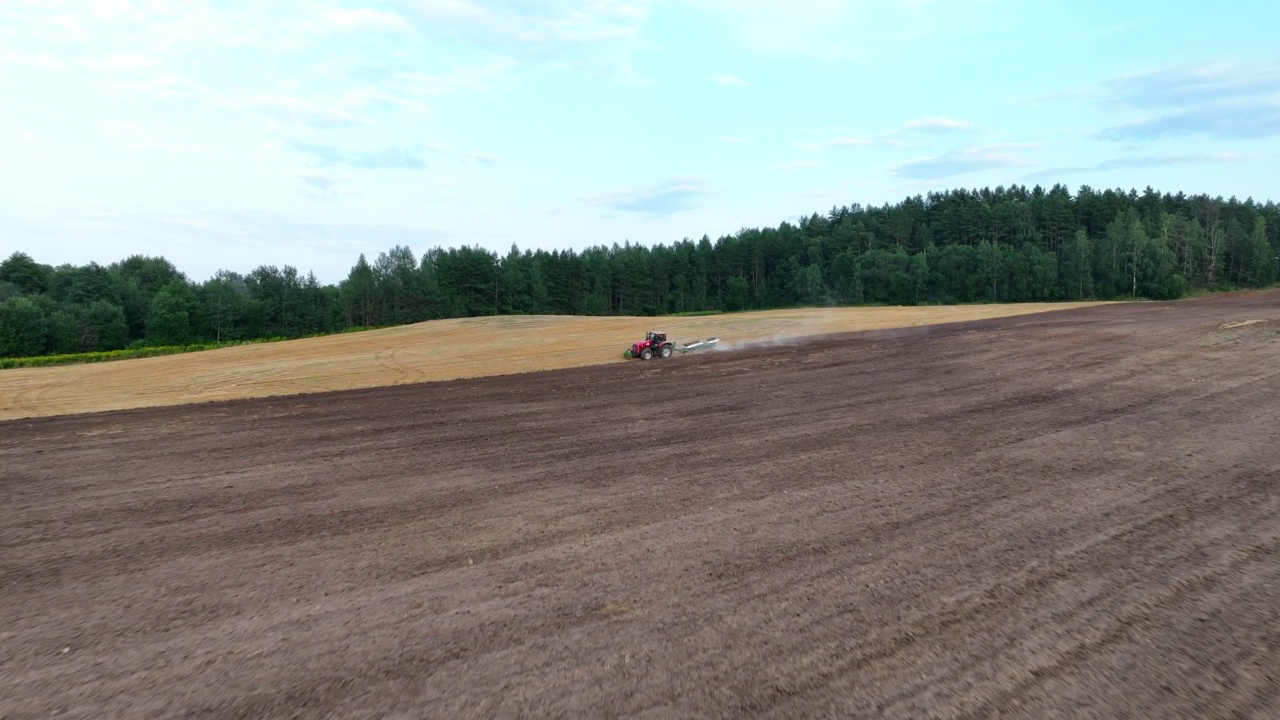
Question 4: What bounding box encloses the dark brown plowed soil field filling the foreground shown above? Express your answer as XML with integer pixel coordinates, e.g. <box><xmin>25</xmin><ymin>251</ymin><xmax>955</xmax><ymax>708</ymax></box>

<box><xmin>0</xmin><ymin>288</ymin><xmax>1280</xmax><ymax>719</ymax></box>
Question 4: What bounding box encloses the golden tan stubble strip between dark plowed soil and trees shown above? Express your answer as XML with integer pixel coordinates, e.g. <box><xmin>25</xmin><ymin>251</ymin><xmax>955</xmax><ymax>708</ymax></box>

<box><xmin>0</xmin><ymin>302</ymin><xmax>1091</xmax><ymax>420</ymax></box>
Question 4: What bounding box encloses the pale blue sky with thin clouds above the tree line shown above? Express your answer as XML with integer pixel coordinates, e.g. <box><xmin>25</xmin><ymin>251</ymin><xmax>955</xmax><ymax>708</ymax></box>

<box><xmin>0</xmin><ymin>0</ymin><xmax>1280</xmax><ymax>283</ymax></box>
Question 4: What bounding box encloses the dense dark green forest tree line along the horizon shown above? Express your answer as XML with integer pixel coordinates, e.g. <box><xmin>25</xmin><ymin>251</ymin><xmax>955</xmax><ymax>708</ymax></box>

<box><xmin>0</xmin><ymin>184</ymin><xmax>1280</xmax><ymax>357</ymax></box>
